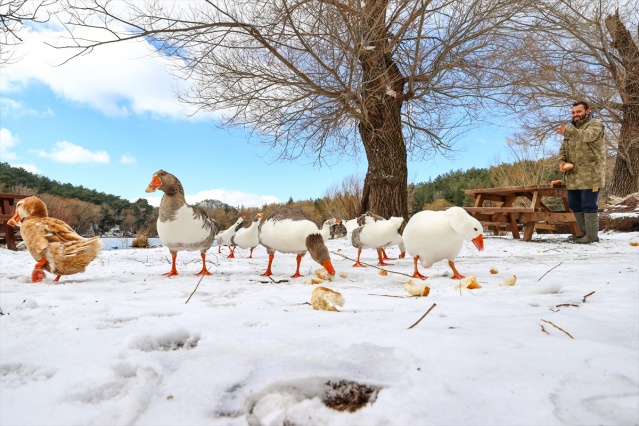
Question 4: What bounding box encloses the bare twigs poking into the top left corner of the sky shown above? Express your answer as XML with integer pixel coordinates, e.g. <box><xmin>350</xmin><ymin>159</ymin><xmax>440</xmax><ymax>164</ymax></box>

<box><xmin>0</xmin><ymin>0</ymin><xmax>53</xmax><ymax>68</ymax></box>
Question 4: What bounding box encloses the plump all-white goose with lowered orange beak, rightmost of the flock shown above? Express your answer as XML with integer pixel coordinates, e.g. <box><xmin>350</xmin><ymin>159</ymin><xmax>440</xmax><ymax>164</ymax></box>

<box><xmin>403</xmin><ymin>207</ymin><xmax>484</xmax><ymax>279</ymax></box>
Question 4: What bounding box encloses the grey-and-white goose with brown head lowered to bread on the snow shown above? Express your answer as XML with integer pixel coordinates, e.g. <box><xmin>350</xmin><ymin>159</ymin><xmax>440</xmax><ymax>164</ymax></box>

<box><xmin>258</xmin><ymin>206</ymin><xmax>339</xmax><ymax>278</ymax></box>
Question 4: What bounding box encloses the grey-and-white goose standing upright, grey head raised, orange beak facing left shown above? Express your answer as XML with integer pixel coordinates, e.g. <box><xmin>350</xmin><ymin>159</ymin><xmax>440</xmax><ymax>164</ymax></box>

<box><xmin>146</xmin><ymin>170</ymin><xmax>215</xmax><ymax>277</ymax></box>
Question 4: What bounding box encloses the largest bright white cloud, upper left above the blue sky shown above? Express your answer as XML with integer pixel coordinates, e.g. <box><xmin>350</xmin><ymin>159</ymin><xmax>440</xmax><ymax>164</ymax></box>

<box><xmin>0</xmin><ymin>26</ymin><xmax>208</xmax><ymax>119</ymax></box>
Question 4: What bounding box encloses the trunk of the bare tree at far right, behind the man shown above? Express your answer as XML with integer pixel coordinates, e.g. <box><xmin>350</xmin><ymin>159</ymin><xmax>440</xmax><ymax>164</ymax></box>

<box><xmin>606</xmin><ymin>11</ymin><xmax>639</xmax><ymax>196</ymax></box>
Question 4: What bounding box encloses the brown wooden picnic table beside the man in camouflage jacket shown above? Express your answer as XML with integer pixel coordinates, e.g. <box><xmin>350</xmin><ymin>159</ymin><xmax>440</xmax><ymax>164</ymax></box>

<box><xmin>464</xmin><ymin>185</ymin><xmax>578</xmax><ymax>241</ymax></box>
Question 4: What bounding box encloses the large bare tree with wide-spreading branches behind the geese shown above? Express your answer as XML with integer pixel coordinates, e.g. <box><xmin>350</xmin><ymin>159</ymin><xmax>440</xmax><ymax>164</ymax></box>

<box><xmin>58</xmin><ymin>0</ymin><xmax>536</xmax><ymax>217</ymax></box>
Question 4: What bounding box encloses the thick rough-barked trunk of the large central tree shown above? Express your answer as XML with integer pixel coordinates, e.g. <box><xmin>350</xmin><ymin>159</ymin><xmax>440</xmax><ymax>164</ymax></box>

<box><xmin>359</xmin><ymin>0</ymin><xmax>408</xmax><ymax>220</ymax></box>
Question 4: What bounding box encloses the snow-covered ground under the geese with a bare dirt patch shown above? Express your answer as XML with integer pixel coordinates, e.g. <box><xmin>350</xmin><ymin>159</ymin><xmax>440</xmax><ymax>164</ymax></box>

<box><xmin>0</xmin><ymin>232</ymin><xmax>639</xmax><ymax>426</ymax></box>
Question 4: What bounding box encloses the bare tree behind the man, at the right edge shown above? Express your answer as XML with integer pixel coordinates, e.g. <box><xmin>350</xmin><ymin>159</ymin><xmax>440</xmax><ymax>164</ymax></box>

<box><xmin>503</xmin><ymin>0</ymin><xmax>639</xmax><ymax>195</ymax></box>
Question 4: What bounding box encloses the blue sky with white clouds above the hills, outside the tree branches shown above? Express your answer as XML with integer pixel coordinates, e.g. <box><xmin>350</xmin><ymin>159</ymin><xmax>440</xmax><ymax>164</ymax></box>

<box><xmin>0</xmin><ymin>22</ymin><xmax>508</xmax><ymax>206</ymax></box>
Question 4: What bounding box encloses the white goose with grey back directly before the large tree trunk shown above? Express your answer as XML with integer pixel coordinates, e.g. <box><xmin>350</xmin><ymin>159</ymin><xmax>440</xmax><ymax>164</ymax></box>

<box><xmin>351</xmin><ymin>212</ymin><xmax>404</xmax><ymax>267</ymax></box>
